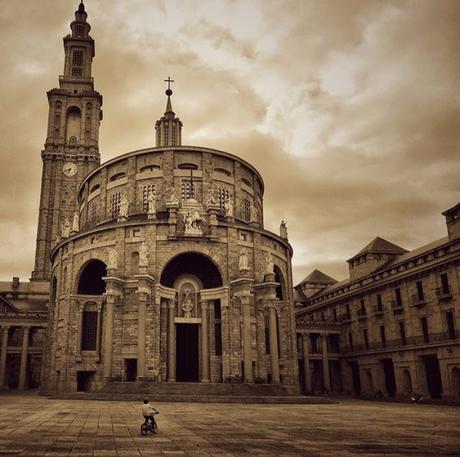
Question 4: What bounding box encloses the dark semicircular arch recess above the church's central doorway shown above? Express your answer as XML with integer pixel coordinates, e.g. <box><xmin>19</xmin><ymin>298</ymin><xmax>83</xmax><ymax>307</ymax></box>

<box><xmin>160</xmin><ymin>252</ymin><xmax>223</xmax><ymax>289</ymax></box>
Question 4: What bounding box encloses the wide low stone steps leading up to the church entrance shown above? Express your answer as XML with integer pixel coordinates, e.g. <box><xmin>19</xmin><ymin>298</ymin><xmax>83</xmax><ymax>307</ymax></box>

<box><xmin>50</xmin><ymin>381</ymin><xmax>333</xmax><ymax>404</ymax></box>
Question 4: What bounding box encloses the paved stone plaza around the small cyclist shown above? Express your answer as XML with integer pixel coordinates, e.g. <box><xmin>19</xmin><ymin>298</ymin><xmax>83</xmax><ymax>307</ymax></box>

<box><xmin>0</xmin><ymin>394</ymin><xmax>460</xmax><ymax>457</ymax></box>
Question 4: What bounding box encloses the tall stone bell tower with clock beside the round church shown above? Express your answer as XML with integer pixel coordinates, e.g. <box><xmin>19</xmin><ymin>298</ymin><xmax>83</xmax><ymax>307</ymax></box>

<box><xmin>32</xmin><ymin>0</ymin><xmax>102</xmax><ymax>280</ymax></box>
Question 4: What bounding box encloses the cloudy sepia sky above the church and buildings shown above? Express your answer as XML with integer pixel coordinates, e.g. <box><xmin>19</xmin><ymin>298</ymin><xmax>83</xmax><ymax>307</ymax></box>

<box><xmin>0</xmin><ymin>0</ymin><xmax>460</xmax><ymax>282</ymax></box>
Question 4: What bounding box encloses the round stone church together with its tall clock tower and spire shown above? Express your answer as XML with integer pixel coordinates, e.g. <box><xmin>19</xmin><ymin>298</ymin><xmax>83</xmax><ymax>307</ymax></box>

<box><xmin>0</xmin><ymin>3</ymin><xmax>298</xmax><ymax>392</ymax></box>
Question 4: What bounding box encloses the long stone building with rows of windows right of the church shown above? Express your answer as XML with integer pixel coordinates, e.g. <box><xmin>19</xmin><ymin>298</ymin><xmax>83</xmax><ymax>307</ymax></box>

<box><xmin>295</xmin><ymin>204</ymin><xmax>460</xmax><ymax>400</ymax></box>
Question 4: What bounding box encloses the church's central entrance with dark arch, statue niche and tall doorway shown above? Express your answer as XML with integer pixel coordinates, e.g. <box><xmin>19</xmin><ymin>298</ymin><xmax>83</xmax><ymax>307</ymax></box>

<box><xmin>160</xmin><ymin>252</ymin><xmax>222</xmax><ymax>382</ymax></box>
